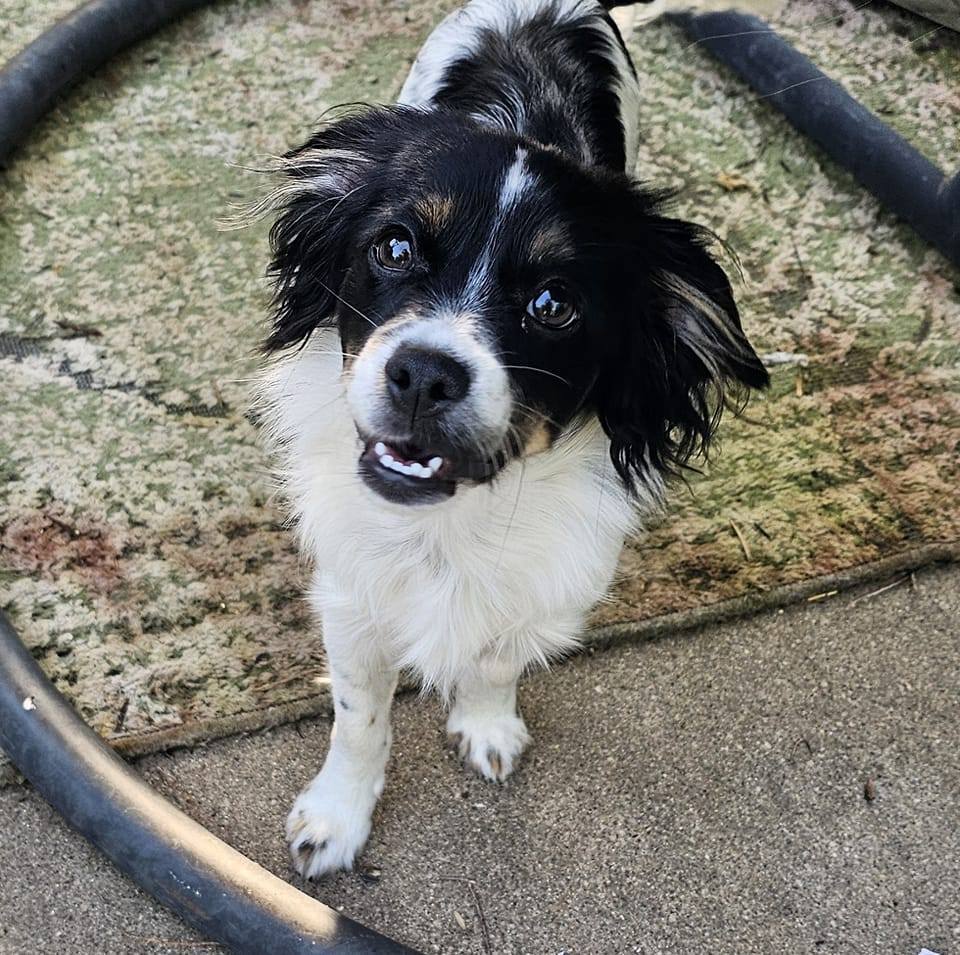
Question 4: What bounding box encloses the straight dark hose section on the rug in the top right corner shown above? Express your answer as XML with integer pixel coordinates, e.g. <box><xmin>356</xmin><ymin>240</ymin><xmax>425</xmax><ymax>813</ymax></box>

<box><xmin>670</xmin><ymin>11</ymin><xmax>960</xmax><ymax>265</ymax></box>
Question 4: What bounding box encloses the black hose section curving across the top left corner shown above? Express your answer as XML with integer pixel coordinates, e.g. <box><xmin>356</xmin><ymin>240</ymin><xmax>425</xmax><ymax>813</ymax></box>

<box><xmin>0</xmin><ymin>0</ymin><xmax>210</xmax><ymax>165</ymax></box>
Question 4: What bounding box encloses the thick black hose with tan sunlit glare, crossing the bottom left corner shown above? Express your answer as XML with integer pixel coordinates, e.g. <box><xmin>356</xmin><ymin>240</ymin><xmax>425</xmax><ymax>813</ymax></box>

<box><xmin>0</xmin><ymin>613</ymin><xmax>413</xmax><ymax>955</ymax></box>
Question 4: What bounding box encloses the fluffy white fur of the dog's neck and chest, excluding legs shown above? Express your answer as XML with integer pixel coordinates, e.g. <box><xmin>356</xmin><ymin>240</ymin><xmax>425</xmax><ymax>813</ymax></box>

<box><xmin>264</xmin><ymin>330</ymin><xmax>658</xmax><ymax>692</ymax></box>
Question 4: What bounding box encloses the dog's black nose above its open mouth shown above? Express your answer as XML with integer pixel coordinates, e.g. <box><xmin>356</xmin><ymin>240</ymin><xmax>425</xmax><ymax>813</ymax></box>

<box><xmin>384</xmin><ymin>345</ymin><xmax>470</xmax><ymax>420</ymax></box>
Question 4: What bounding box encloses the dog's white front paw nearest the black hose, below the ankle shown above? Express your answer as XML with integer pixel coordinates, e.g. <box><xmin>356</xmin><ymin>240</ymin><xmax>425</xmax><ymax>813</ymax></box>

<box><xmin>287</xmin><ymin>772</ymin><xmax>377</xmax><ymax>879</ymax></box>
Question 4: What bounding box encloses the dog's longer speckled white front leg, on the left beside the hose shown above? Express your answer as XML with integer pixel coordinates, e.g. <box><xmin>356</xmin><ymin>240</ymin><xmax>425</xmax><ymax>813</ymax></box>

<box><xmin>287</xmin><ymin>611</ymin><xmax>397</xmax><ymax>879</ymax></box>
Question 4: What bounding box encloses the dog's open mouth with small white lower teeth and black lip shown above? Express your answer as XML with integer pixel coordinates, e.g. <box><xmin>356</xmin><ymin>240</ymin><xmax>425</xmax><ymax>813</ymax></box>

<box><xmin>360</xmin><ymin>438</ymin><xmax>458</xmax><ymax>504</ymax></box>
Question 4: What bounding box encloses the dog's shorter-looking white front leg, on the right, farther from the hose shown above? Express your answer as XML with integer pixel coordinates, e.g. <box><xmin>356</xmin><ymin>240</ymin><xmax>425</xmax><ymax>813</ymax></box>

<box><xmin>447</xmin><ymin>654</ymin><xmax>530</xmax><ymax>782</ymax></box>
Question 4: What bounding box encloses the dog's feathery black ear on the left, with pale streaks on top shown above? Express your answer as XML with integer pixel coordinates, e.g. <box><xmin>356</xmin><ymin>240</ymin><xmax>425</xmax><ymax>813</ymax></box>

<box><xmin>263</xmin><ymin>107</ymin><xmax>422</xmax><ymax>352</ymax></box>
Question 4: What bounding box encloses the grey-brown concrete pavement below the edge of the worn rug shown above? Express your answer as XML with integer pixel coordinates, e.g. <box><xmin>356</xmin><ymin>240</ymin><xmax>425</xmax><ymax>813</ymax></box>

<box><xmin>0</xmin><ymin>567</ymin><xmax>960</xmax><ymax>955</ymax></box>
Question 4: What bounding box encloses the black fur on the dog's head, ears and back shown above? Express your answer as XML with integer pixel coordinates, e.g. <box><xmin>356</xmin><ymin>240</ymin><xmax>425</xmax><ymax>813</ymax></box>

<box><xmin>265</xmin><ymin>0</ymin><xmax>768</xmax><ymax>487</ymax></box>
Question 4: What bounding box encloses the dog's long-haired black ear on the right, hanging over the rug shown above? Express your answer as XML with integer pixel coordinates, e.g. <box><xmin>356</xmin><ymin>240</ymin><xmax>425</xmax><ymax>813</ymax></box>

<box><xmin>597</xmin><ymin>210</ymin><xmax>769</xmax><ymax>488</ymax></box>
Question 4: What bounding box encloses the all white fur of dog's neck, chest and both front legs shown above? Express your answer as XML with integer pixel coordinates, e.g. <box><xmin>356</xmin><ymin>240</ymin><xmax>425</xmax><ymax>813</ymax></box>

<box><xmin>260</xmin><ymin>330</ymin><xmax>662</xmax><ymax>877</ymax></box>
